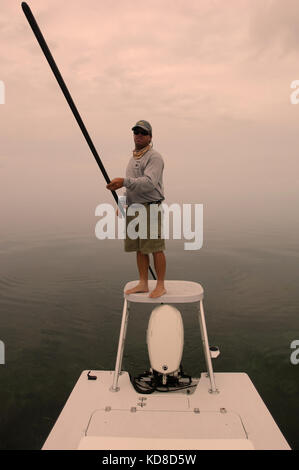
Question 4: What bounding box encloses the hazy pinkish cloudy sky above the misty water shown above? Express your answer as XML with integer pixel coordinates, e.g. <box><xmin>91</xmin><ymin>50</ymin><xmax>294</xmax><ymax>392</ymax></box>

<box><xmin>0</xmin><ymin>0</ymin><xmax>299</xmax><ymax>235</ymax></box>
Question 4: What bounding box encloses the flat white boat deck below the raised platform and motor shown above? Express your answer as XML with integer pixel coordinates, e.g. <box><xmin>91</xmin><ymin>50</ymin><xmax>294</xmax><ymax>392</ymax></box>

<box><xmin>43</xmin><ymin>371</ymin><xmax>289</xmax><ymax>450</ymax></box>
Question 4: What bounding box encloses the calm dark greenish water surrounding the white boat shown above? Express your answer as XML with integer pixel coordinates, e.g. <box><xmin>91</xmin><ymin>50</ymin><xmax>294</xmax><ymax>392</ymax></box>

<box><xmin>0</xmin><ymin>232</ymin><xmax>299</xmax><ymax>449</ymax></box>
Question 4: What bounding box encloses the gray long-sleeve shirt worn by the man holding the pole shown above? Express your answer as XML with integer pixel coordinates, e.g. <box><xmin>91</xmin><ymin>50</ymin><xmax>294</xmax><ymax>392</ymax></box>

<box><xmin>124</xmin><ymin>148</ymin><xmax>165</xmax><ymax>205</ymax></box>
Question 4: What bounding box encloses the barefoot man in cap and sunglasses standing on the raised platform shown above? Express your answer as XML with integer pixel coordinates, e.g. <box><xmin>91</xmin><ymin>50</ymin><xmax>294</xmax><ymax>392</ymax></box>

<box><xmin>106</xmin><ymin>120</ymin><xmax>166</xmax><ymax>298</ymax></box>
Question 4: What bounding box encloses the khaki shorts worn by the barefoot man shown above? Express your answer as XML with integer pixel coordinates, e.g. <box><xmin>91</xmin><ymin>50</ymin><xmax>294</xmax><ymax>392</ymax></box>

<box><xmin>124</xmin><ymin>203</ymin><xmax>165</xmax><ymax>254</ymax></box>
